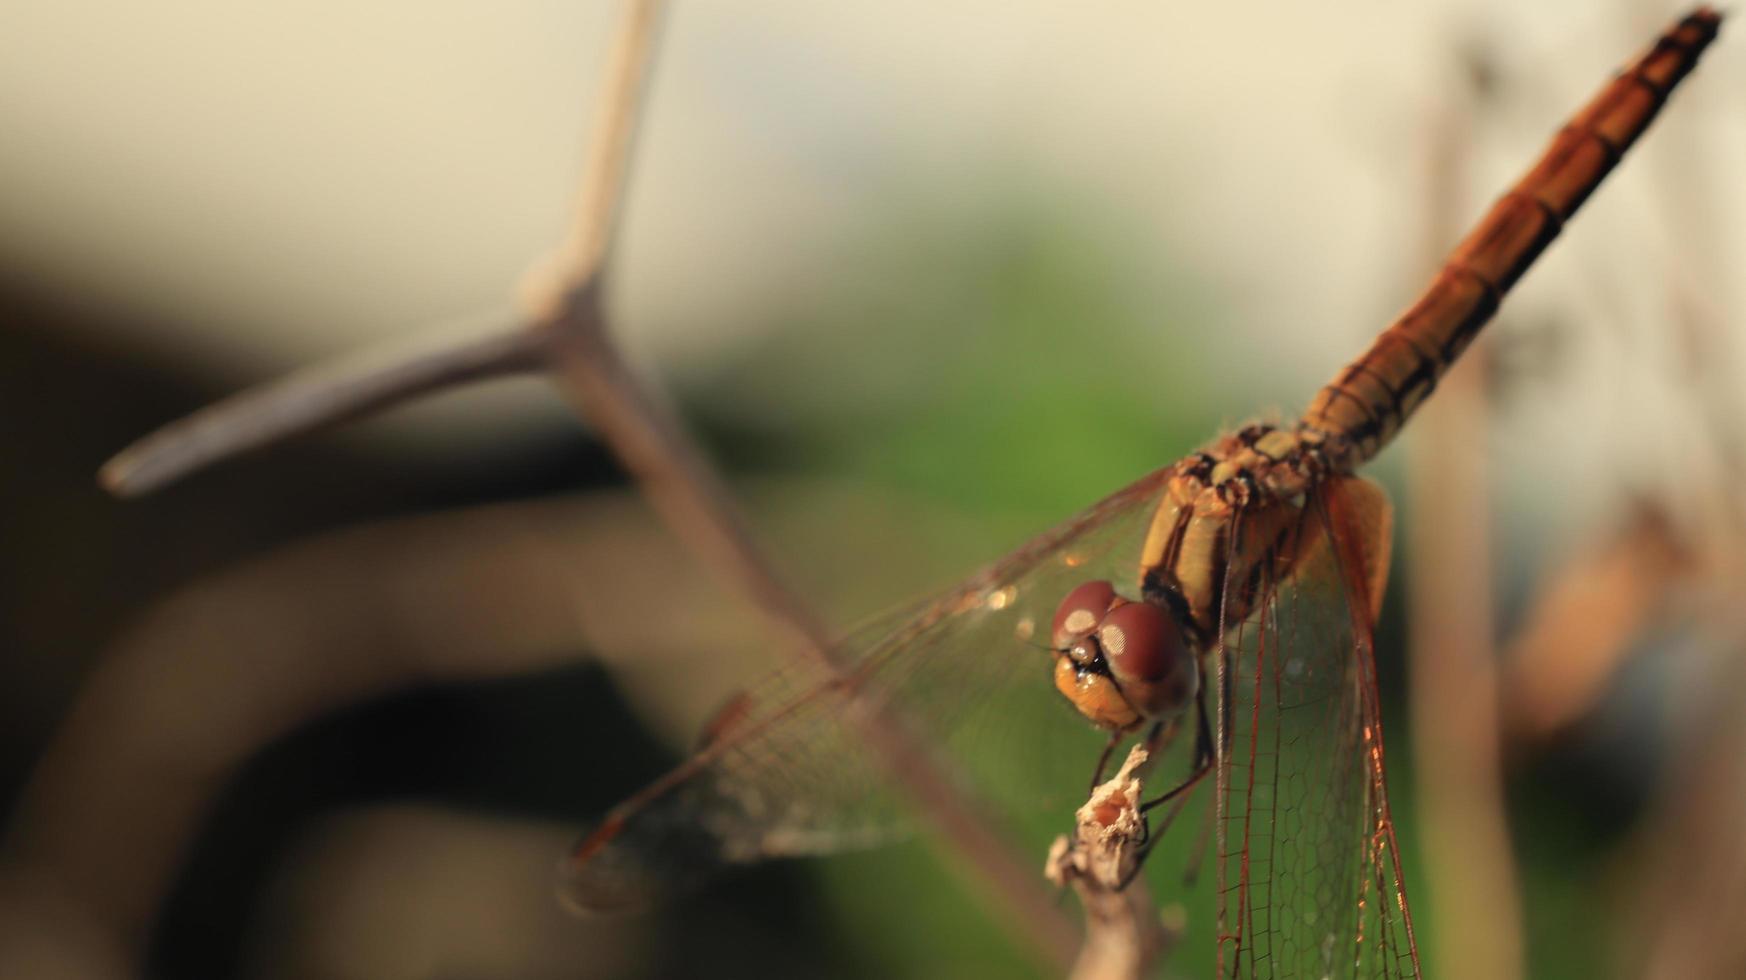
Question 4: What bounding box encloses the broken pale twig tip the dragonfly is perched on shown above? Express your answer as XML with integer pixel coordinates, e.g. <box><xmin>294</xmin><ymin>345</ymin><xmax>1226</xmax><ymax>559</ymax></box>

<box><xmin>1044</xmin><ymin>746</ymin><xmax>1170</xmax><ymax>980</ymax></box>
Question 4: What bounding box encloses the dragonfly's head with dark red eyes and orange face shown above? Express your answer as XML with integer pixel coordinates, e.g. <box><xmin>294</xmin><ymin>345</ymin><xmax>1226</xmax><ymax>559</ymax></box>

<box><xmin>1051</xmin><ymin>580</ymin><xmax>1200</xmax><ymax>730</ymax></box>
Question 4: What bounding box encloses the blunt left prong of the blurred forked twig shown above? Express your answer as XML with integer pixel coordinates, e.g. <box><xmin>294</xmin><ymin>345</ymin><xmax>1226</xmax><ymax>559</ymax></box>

<box><xmin>98</xmin><ymin>330</ymin><xmax>543</xmax><ymax>496</ymax></box>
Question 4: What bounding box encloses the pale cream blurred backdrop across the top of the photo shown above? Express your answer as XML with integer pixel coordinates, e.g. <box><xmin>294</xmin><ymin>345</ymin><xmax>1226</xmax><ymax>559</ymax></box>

<box><xmin>0</xmin><ymin>0</ymin><xmax>1746</xmax><ymax>541</ymax></box>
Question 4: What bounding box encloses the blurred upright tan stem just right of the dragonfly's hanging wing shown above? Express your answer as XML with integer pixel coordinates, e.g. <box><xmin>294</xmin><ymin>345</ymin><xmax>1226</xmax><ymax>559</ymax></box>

<box><xmin>1407</xmin><ymin>69</ymin><xmax>1523</xmax><ymax>980</ymax></box>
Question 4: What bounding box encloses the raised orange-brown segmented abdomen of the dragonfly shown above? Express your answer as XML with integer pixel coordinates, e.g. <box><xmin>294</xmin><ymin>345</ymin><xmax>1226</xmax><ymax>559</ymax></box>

<box><xmin>1303</xmin><ymin>7</ymin><xmax>1720</xmax><ymax>466</ymax></box>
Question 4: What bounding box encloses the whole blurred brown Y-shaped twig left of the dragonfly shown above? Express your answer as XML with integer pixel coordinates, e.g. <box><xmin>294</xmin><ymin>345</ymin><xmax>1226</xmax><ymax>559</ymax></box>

<box><xmin>101</xmin><ymin>0</ymin><xmax>1077</xmax><ymax>964</ymax></box>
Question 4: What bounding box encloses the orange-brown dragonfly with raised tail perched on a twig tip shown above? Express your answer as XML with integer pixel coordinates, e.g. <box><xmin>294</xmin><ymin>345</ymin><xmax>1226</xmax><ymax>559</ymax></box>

<box><xmin>564</xmin><ymin>7</ymin><xmax>1720</xmax><ymax>977</ymax></box>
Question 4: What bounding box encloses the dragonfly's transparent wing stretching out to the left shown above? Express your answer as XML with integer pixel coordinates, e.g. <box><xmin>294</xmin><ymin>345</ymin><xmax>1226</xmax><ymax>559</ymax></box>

<box><xmin>564</xmin><ymin>468</ymin><xmax>1173</xmax><ymax>910</ymax></box>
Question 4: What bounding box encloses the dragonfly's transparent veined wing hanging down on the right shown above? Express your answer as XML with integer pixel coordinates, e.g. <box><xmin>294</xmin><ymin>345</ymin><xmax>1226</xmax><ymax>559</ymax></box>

<box><xmin>1215</xmin><ymin>479</ymin><xmax>1419</xmax><ymax>977</ymax></box>
